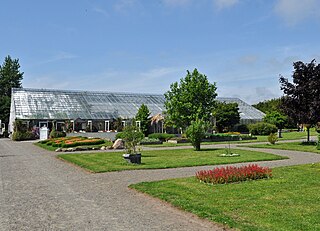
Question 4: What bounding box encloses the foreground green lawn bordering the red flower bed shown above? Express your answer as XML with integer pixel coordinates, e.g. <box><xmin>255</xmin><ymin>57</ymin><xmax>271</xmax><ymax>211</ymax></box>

<box><xmin>130</xmin><ymin>164</ymin><xmax>320</xmax><ymax>231</ymax></box>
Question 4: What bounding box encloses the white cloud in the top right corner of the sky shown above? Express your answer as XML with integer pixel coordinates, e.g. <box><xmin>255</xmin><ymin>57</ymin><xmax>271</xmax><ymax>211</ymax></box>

<box><xmin>274</xmin><ymin>0</ymin><xmax>320</xmax><ymax>26</ymax></box>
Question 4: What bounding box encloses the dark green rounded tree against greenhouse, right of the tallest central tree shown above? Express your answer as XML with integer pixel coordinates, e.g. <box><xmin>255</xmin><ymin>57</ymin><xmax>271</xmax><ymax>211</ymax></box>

<box><xmin>213</xmin><ymin>102</ymin><xmax>240</xmax><ymax>132</ymax></box>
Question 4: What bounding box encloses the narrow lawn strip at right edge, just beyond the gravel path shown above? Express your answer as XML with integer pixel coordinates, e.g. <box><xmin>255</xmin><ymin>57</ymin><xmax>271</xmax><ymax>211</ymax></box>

<box><xmin>242</xmin><ymin>142</ymin><xmax>320</xmax><ymax>153</ymax></box>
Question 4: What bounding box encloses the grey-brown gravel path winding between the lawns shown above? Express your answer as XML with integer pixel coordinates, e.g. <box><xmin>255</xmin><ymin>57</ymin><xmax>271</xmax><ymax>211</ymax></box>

<box><xmin>0</xmin><ymin>139</ymin><xmax>320</xmax><ymax>231</ymax></box>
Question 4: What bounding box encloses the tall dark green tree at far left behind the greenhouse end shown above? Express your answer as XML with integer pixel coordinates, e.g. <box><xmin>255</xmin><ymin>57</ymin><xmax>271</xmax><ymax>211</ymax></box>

<box><xmin>0</xmin><ymin>55</ymin><xmax>23</xmax><ymax>124</ymax></box>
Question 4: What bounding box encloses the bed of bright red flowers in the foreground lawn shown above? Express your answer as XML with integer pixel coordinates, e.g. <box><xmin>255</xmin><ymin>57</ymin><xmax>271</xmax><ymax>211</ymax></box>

<box><xmin>196</xmin><ymin>164</ymin><xmax>272</xmax><ymax>184</ymax></box>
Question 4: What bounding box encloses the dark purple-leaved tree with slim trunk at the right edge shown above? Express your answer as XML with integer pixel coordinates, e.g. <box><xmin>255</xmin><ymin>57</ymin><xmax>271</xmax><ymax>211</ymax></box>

<box><xmin>279</xmin><ymin>60</ymin><xmax>320</xmax><ymax>141</ymax></box>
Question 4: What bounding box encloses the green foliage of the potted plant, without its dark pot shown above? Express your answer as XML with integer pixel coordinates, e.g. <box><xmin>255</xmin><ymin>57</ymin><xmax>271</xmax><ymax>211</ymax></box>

<box><xmin>123</xmin><ymin>125</ymin><xmax>144</xmax><ymax>154</ymax></box>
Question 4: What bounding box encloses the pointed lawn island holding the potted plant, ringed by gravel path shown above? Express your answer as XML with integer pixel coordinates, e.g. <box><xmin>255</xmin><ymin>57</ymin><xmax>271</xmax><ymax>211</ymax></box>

<box><xmin>58</xmin><ymin>149</ymin><xmax>285</xmax><ymax>172</ymax></box>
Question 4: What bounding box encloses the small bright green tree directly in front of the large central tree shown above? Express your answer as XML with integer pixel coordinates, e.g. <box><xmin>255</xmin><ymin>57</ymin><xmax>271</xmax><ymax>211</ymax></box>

<box><xmin>186</xmin><ymin>119</ymin><xmax>208</xmax><ymax>151</ymax></box>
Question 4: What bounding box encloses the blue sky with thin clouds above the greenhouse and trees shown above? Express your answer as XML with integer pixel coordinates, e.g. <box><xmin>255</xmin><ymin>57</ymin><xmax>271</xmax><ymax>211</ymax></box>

<box><xmin>0</xmin><ymin>0</ymin><xmax>320</xmax><ymax>103</ymax></box>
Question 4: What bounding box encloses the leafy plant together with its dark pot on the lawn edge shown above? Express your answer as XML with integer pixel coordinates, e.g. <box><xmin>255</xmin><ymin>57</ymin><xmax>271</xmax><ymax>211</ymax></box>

<box><xmin>122</xmin><ymin>125</ymin><xmax>144</xmax><ymax>164</ymax></box>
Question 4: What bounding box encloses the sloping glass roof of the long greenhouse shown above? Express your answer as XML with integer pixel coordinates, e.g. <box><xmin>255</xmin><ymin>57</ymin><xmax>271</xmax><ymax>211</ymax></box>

<box><xmin>12</xmin><ymin>88</ymin><xmax>264</xmax><ymax>120</ymax></box>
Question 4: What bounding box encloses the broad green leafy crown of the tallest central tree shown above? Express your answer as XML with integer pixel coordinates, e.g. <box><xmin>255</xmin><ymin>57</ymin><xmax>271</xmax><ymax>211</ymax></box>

<box><xmin>165</xmin><ymin>69</ymin><xmax>217</xmax><ymax>129</ymax></box>
